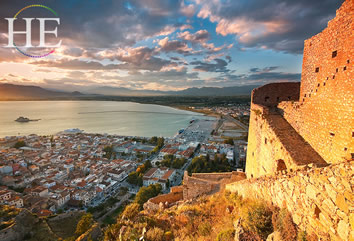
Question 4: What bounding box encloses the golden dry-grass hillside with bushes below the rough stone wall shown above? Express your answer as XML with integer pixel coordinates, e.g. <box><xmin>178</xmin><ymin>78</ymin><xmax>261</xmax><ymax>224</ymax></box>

<box><xmin>104</xmin><ymin>192</ymin><xmax>304</xmax><ymax>241</ymax></box>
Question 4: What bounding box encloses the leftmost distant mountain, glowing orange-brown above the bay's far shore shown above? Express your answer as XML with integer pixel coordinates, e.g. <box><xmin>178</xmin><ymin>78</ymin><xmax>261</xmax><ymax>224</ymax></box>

<box><xmin>0</xmin><ymin>84</ymin><xmax>82</xmax><ymax>100</ymax></box>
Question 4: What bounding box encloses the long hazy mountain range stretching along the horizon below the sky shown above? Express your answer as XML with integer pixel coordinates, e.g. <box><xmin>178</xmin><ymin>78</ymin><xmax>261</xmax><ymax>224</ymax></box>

<box><xmin>0</xmin><ymin>84</ymin><xmax>258</xmax><ymax>100</ymax></box>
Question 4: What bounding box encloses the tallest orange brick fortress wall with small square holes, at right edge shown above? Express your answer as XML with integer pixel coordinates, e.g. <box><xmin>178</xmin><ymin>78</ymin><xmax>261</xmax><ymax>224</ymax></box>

<box><xmin>278</xmin><ymin>0</ymin><xmax>354</xmax><ymax>163</ymax></box>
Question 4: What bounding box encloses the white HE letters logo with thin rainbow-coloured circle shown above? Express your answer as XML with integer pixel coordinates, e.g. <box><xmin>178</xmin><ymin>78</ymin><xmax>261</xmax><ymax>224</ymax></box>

<box><xmin>5</xmin><ymin>4</ymin><xmax>61</xmax><ymax>58</ymax></box>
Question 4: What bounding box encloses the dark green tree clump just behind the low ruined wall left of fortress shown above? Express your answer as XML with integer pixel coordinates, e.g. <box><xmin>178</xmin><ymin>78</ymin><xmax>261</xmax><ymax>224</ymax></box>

<box><xmin>187</xmin><ymin>155</ymin><xmax>232</xmax><ymax>173</ymax></box>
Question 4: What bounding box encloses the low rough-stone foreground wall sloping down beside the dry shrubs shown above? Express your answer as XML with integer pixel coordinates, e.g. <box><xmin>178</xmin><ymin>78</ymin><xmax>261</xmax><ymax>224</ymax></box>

<box><xmin>225</xmin><ymin>161</ymin><xmax>354</xmax><ymax>240</ymax></box>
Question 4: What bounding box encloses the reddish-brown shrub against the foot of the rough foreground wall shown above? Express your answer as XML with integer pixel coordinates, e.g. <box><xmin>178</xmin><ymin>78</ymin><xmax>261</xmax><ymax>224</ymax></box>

<box><xmin>272</xmin><ymin>208</ymin><xmax>297</xmax><ymax>241</ymax></box>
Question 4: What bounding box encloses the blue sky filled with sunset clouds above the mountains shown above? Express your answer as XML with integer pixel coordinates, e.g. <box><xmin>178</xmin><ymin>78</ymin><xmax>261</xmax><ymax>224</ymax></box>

<box><xmin>0</xmin><ymin>0</ymin><xmax>343</xmax><ymax>91</ymax></box>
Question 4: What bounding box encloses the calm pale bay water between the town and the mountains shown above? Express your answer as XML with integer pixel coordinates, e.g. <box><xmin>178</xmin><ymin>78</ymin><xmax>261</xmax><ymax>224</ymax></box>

<box><xmin>0</xmin><ymin>101</ymin><xmax>211</xmax><ymax>137</ymax></box>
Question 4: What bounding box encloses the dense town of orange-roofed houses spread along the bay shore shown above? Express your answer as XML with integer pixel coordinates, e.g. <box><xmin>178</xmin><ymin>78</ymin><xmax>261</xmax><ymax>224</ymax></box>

<box><xmin>0</xmin><ymin>106</ymin><xmax>249</xmax><ymax>222</ymax></box>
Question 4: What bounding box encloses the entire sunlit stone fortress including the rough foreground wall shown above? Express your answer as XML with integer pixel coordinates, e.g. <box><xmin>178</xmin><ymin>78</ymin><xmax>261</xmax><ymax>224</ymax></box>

<box><xmin>225</xmin><ymin>0</ymin><xmax>354</xmax><ymax>240</ymax></box>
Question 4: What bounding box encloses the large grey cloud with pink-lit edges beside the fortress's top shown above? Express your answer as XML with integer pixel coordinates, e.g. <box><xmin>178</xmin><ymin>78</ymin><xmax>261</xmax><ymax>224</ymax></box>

<box><xmin>195</xmin><ymin>0</ymin><xmax>343</xmax><ymax>53</ymax></box>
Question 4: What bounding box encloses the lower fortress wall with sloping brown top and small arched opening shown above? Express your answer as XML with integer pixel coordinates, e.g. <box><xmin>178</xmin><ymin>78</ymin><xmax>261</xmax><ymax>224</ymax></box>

<box><xmin>246</xmin><ymin>96</ymin><xmax>327</xmax><ymax>178</ymax></box>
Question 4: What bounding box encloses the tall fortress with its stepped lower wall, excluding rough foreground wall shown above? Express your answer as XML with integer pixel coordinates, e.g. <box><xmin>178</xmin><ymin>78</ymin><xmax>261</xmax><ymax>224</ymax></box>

<box><xmin>246</xmin><ymin>0</ymin><xmax>354</xmax><ymax>177</ymax></box>
